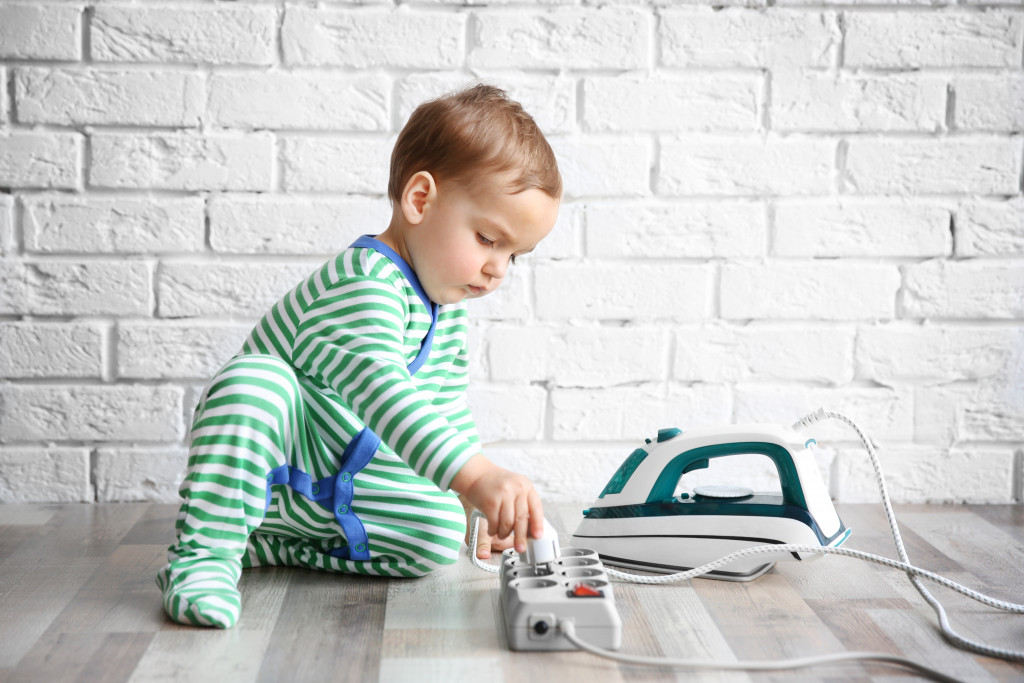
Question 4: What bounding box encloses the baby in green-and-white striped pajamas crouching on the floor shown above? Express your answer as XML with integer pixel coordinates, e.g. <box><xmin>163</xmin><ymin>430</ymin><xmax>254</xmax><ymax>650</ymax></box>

<box><xmin>157</xmin><ymin>85</ymin><xmax>561</xmax><ymax>628</ymax></box>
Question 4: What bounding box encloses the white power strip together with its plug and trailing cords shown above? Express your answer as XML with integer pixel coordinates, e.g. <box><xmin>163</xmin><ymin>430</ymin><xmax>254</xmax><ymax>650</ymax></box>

<box><xmin>469</xmin><ymin>409</ymin><xmax>1024</xmax><ymax>683</ymax></box>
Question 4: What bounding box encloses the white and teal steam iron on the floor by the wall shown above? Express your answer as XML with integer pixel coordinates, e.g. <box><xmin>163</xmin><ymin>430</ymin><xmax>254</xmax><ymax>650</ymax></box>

<box><xmin>571</xmin><ymin>424</ymin><xmax>850</xmax><ymax>581</ymax></box>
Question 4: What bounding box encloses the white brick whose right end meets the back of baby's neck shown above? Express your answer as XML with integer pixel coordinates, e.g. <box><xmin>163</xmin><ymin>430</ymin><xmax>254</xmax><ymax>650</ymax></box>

<box><xmin>210</xmin><ymin>195</ymin><xmax>391</xmax><ymax>255</ymax></box>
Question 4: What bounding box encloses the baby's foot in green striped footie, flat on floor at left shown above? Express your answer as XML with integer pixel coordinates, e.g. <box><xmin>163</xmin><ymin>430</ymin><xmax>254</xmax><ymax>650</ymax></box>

<box><xmin>157</xmin><ymin>557</ymin><xmax>242</xmax><ymax>629</ymax></box>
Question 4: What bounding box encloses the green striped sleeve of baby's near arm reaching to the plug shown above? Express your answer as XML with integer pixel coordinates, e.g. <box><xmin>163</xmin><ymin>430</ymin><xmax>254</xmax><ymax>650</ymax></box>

<box><xmin>292</xmin><ymin>276</ymin><xmax>476</xmax><ymax>489</ymax></box>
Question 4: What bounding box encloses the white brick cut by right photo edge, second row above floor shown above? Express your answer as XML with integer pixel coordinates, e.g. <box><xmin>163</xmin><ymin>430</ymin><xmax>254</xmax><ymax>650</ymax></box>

<box><xmin>913</xmin><ymin>385</ymin><xmax>1024</xmax><ymax>447</ymax></box>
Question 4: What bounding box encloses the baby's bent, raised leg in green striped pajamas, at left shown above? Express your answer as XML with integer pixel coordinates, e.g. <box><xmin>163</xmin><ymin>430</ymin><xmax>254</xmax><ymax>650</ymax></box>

<box><xmin>157</xmin><ymin>355</ymin><xmax>308</xmax><ymax>628</ymax></box>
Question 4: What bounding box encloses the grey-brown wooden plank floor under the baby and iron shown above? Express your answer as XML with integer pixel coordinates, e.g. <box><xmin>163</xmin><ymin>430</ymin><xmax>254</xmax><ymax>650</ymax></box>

<box><xmin>0</xmin><ymin>504</ymin><xmax>1024</xmax><ymax>683</ymax></box>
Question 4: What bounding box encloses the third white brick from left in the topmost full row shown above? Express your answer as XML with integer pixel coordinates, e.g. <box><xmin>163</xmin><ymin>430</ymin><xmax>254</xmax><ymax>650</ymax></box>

<box><xmin>281</xmin><ymin>6</ymin><xmax>466</xmax><ymax>69</ymax></box>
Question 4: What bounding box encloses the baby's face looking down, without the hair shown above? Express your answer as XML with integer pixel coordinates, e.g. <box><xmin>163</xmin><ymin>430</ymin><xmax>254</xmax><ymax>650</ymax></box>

<box><xmin>407</xmin><ymin>175</ymin><xmax>558</xmax><ymax>304</ymax></box>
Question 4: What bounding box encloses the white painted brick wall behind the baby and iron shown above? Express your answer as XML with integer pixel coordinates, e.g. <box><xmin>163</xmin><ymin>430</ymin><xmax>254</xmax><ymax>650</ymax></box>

<box><xmin>0</xmin><ymin>0</ymin><xmax>1024</xmax><ymax>503</ymax></box>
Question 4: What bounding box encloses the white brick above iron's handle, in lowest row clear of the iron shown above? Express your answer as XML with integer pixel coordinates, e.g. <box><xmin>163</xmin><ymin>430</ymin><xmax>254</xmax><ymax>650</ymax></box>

<box><xmin>673</xmin><ymin>325</ymin><xmax>854</xmax><ymax>384</ymax></box>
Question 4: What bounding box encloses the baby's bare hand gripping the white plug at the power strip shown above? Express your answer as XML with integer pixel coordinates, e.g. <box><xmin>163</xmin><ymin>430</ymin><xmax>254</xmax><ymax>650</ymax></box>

<box><xmin>452</xmin><ymin>455</ymin><xmax>544</xmax><ymax>557</ymax></box>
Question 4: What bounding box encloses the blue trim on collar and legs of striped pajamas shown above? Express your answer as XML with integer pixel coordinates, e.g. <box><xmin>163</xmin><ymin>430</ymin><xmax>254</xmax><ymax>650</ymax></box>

<box><xmin>264</xmin><ymin>234</ymin><xmax>438</xmax><ymax>560</ymax></box>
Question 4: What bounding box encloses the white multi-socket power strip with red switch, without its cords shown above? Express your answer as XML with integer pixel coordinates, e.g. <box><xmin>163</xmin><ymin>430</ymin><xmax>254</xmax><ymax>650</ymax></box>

<box><xmin>500</xmin><ymin>548</ymin><xmax>623</xmax><ymax>650</ymax></box>
